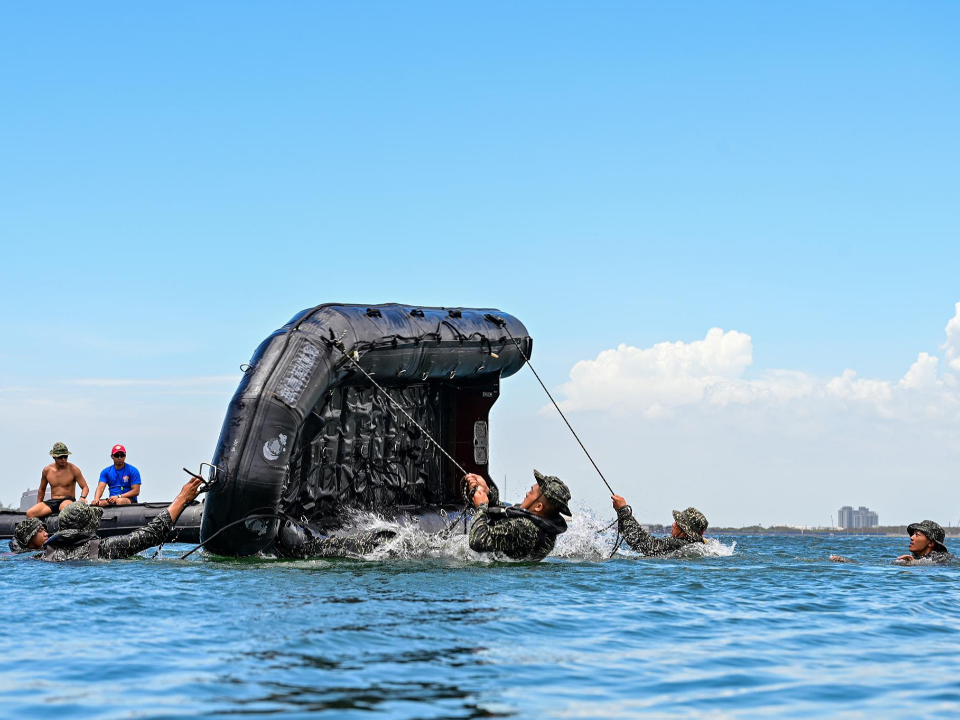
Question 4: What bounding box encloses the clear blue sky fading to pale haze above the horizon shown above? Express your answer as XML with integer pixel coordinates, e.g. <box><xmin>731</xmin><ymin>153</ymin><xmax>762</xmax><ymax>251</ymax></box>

<box><xmin>0</xmin><ymin>2</ymin><xmax>960</xmax><ymax>523</ymax></box>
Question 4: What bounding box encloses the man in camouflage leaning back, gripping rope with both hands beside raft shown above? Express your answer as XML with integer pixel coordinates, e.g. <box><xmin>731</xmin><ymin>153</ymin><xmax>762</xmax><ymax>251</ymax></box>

<box><xmin>464</xmin><ymin>470</ymin><xmax>570</xmax><ymax>560</ymax></box>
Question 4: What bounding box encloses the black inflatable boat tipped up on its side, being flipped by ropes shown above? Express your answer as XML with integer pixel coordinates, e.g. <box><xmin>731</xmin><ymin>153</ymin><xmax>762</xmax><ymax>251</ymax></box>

<box><xmin>200</xmin><ymin>304</ymin><xmax>533</xmax><ymax>556</ymax></box>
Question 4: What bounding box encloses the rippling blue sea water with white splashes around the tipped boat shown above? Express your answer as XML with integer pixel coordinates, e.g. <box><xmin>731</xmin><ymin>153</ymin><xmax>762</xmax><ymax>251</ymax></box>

<box><xmin>0</xmin><ymin>518</ymin><xmax>960</xmax><ymax>720</ymax></box>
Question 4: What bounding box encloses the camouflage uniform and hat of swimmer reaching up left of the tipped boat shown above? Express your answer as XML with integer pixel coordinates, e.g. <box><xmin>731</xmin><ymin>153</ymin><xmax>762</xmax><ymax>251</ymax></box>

<box><xmin>37</xmin><ymin>502</ymin><xmax>174</xmax><ymax>562</ymax></box>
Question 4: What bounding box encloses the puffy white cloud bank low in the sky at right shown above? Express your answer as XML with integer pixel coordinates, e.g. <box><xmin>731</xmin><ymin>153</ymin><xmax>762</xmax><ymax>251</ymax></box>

<box><xmin>561</xmin><ymin>303</ymin><xmax>960</xmax><ymax>421</ymax></box>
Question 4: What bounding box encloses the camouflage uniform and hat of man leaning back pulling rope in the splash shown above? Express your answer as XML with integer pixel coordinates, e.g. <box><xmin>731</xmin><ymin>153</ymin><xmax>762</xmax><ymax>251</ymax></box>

<box><xmin>470</xmin><ymin>470</ymin><xmax>570</xmax><ymax>561</ymax></box>
